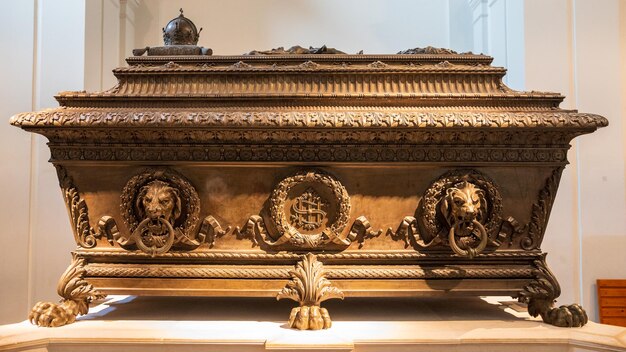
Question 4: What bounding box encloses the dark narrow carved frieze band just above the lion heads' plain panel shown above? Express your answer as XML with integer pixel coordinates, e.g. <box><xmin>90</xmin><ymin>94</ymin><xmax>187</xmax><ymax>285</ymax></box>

<box><xmin>45</xmin><ymin>144</ymin><xmax>567</xmax><ymax>164</ymax></box>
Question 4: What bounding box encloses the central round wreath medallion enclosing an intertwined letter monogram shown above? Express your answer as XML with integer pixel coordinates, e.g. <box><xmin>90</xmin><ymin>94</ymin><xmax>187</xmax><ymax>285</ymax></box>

<box><xmin>268</xmin><ymin>171</ymin><xmax>350</xmax><ymax>249</ymax></box>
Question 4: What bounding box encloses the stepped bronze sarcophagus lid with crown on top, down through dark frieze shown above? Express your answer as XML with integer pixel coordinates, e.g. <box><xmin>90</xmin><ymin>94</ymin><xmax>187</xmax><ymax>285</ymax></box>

<box><xmin>11</xmin><ymin>10</ymin><xmax>608</xmax><ymax>162</ymax></box>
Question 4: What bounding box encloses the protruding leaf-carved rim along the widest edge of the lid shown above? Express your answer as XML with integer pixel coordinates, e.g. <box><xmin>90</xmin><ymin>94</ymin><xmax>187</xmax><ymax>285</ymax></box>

<box><xmin>11</xmin><ymin>108</ymin><xmax>608</xmax><ymax>129</ymax></box>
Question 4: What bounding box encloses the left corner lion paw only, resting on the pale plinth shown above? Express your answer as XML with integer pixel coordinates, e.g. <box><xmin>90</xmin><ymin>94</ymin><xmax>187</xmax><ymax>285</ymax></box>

<box><xmin>28</xmin><ymin>300</ymin><xmax>88</xmax><ymax>327</ymax></box>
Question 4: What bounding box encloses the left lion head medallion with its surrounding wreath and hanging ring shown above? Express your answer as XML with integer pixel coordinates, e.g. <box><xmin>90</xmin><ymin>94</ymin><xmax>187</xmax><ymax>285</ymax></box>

<box><xmin>119</xmin><ymin>169</ymin><xmax>200</xmax><ymax>256</ymax></box>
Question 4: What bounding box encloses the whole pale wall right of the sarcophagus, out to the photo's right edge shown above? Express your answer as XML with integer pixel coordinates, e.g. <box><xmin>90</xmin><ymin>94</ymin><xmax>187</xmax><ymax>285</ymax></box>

<box><xmin>525</xmin><ymin>0</ymin><xmax>626</xmax><ymax>320</ymax></box>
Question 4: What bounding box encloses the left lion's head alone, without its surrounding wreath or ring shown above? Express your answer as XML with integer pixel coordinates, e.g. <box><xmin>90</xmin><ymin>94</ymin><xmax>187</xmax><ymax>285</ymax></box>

<box><xmin>135</xmin><ymin>180</ymin><xmax>182</xmax><ymax>226</ymax></box>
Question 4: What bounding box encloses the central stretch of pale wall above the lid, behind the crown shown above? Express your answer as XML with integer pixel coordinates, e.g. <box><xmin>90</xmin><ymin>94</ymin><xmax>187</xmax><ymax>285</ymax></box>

<box><xmin>135</xmin><ymin>0</ymin><xmax>450</xmax><ymax>55</ymax></box>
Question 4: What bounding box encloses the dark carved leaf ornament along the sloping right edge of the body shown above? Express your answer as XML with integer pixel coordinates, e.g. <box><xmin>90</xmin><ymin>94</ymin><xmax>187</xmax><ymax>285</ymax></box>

<box><xmin>520</xmin><ymin>167</ymin><xmax>564</xmax><ymax>250</ymax></box>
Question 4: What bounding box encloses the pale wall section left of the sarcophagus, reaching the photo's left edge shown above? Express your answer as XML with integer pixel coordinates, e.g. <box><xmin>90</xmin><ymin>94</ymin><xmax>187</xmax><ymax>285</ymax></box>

<box><xmin>0</xmin><ymin>0</ymin><xmax>85</xmax><ymax>322</ymax></box>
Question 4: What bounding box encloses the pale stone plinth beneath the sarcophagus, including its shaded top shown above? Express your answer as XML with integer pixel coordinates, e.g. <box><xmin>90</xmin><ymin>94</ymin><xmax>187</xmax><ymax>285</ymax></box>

<box><xmin>0</xmin><ymin>296</ymin><xmax>626</xmax><ymax>352</ymax></box>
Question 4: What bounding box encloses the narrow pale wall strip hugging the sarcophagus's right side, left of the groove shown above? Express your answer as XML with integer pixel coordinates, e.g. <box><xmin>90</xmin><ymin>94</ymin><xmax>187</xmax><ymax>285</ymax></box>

<box><xmin>524</xmin><ymin>0</ymin><xmax>576</xmax><ymax>308</ymax></box>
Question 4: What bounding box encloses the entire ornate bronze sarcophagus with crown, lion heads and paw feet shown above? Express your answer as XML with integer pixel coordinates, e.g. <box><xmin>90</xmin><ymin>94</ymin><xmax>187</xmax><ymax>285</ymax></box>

<box><xmin>11</xmin><ymin>14</ymin><xmax>608</xmax><ymax>329</ymax></box>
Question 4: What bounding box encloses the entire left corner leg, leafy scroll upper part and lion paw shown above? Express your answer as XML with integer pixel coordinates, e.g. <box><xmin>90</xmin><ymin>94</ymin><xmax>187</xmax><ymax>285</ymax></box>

<box><xmin>28</xmin><ymin>257</ymin><xmax>104</xmax><ymax>327</ymax></box>
